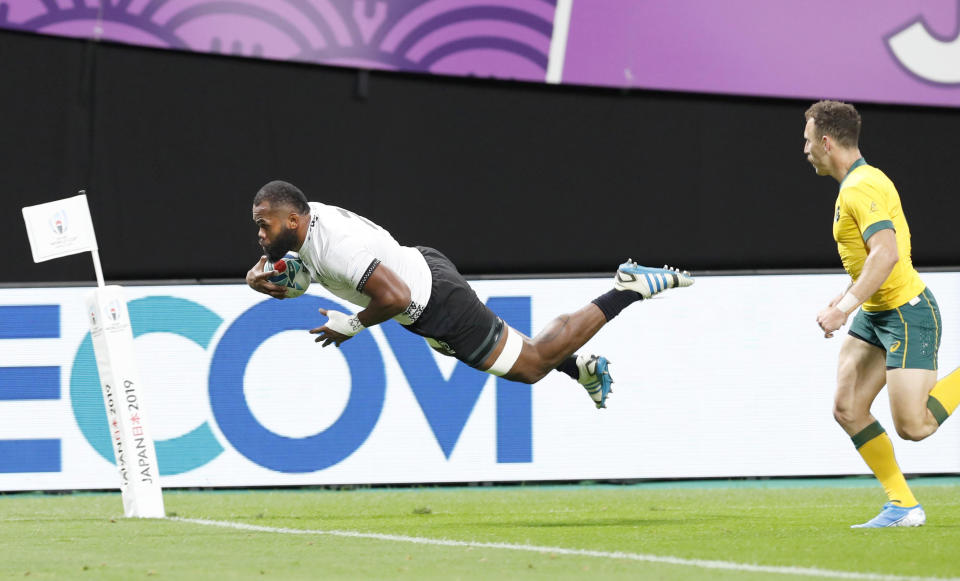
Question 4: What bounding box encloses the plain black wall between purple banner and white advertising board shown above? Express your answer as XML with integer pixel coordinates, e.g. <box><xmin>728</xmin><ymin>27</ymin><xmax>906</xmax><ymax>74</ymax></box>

<box><xmin>0</xmin><ymin>32</ymin><xmax>960</xmax><ymax>283</ymax></box>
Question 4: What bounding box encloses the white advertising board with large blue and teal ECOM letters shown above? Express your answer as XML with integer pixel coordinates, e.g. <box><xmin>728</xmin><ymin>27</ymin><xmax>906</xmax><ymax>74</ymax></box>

<box><xmin>0</xmin><ymin>273</ymin><xmax>960</xmax><ymax>490</ymax></box>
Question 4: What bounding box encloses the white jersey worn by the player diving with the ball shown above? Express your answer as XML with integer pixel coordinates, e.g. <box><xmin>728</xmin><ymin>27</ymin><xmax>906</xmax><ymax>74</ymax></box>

<box><xmin>299</xmin><ymin>202</ymin><xmax>433</xmax><ymax>325</ymax></box>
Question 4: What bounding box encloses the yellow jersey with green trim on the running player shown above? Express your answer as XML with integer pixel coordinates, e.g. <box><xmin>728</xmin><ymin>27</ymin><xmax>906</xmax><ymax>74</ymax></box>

<box><xmin>833</xmin><ymin>158</ymin><xmax>926</xmax><ymax>311</ymax></box>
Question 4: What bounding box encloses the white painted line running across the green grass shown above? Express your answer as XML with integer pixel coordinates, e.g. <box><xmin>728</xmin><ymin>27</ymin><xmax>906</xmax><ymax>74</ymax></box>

<box><xmin>174</xmin><ymin>517</ymin><xmax>960</xmax><ymax>581</ymax></box>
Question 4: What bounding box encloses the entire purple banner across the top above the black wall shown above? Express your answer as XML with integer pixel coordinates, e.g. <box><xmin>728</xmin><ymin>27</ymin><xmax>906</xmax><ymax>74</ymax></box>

<box><xmin>0</xmin><ymin>0</ymin><xmax>960</xmax><ymax>107</ymax></box>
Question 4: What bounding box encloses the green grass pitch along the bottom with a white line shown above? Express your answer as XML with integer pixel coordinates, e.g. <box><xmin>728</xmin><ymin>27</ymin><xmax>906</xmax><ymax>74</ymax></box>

<box><xmin>0</xmin><ymin>478</ymin><xmax>960</xmax><ymax>581</ymax></box>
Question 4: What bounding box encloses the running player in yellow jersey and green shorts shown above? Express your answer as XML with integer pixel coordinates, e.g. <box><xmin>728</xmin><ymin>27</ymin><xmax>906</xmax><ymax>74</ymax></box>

<box><xmin>803</xmin><ymin>101</ymin><xmax>960</xmax><ymax>528</ymax></box>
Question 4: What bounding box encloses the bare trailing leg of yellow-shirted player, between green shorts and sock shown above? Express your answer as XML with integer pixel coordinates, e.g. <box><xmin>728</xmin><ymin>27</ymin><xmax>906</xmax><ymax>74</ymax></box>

<box><xmin>887</xmin><ymin>369</ymin><xmax>940</xmax><ymax>441</ymax></box>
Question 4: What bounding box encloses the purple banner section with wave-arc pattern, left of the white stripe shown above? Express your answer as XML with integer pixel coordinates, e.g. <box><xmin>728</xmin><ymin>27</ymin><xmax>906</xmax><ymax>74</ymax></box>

<box><xmin>0</xmin><ymin>0</ymin><xmax>556</xmax><ymax>81</ymax></box>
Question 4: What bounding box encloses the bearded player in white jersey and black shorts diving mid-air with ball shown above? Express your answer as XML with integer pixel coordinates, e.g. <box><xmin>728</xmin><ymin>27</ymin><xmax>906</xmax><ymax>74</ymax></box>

<box><xmin>246</xmin><ymin>181</ymin><xmax>693</xmax><ymax>408</ymax></box>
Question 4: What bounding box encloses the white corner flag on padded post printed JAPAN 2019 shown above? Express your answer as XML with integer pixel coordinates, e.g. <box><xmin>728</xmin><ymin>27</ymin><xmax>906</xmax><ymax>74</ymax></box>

<box><xmin>23</xmin><ymin>192</ymin><xmax>166</xmax><ymax>518</ymax></box>
